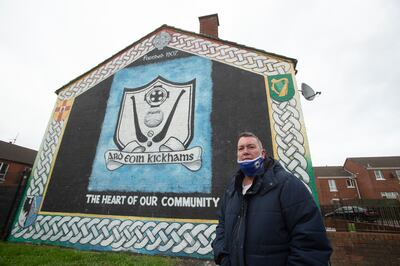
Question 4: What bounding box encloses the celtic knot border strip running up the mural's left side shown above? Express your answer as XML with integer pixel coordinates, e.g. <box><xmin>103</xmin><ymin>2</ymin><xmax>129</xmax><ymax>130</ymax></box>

<box><xmin>27</xmin><ymin>120</ymin><xmax>64</xmax><ymax>195</ymax></box>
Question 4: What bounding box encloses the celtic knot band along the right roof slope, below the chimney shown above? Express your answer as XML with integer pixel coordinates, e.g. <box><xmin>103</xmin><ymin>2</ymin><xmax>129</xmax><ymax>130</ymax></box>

<box><xmin>168</xmin><ymin>33</ymin><xmax>291</xmax><ymax>75</ymax></box>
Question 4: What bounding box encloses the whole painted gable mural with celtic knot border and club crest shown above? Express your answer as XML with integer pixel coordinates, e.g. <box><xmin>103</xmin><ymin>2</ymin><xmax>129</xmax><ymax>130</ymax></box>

<box><xmin>9</xmin><ymin>26</ymin><xmax>316</xmax><ymax>259</ymax></box>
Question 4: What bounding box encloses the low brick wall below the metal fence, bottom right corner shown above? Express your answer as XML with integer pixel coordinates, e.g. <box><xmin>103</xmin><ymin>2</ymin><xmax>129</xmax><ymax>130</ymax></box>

<box><xmin>328</xmin><ymin>232</ymin><xmax>400</xmax><ymax>266</ymax></box>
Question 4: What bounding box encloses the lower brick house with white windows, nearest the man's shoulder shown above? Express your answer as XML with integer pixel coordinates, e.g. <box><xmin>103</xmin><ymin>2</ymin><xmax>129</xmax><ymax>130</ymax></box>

<box><xmin>314</xmin><ymin>166</ymin><xmax>360</xmax><ymax>205</ymax></box>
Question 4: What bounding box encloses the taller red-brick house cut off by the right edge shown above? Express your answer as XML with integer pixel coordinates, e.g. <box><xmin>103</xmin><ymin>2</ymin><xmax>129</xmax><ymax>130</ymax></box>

<box><xmin>343</xmin><ymin>156</ymin><xmax>400</xmax><ymax>199</ymax></box>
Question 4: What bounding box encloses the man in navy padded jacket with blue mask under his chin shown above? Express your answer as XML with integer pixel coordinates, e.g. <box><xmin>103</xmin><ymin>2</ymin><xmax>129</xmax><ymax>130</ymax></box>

<box><xmin>212</xmin><ymin>132</ymin><xmax>332</xmax><ymax>266</ymax></box>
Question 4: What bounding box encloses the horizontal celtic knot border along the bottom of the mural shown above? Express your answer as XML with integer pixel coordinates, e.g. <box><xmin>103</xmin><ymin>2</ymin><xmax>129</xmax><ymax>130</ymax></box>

<box><xmin>12</xmin><ymin>215</ymin><xmax>216</xmax><ymax>255</ymax></box>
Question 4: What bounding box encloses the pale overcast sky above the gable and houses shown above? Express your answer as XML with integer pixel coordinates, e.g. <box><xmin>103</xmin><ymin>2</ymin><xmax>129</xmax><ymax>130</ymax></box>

<box><xmin>0</xmin><ymin>0</ymin><xmax>400</xmax><ymax>166</ymax></box>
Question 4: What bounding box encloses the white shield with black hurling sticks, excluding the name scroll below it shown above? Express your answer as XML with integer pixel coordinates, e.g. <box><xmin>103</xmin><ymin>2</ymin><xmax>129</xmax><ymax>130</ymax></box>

<box><xmin>114</xmin><ymin>76</ymin><xmax>195</xmax><ymax>152</ymax></box>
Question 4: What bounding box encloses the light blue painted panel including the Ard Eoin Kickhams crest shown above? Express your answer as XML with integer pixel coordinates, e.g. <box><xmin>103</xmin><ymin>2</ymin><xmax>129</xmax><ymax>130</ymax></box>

<box><xmin>89</xmin><ymin>56</ymin><xmax>212</xmax><ymax>193</ymax></box>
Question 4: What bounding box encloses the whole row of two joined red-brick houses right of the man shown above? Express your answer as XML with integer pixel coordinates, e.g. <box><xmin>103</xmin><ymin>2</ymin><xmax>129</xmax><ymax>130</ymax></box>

<box><xmin>314</xmin><ymin>156</ymin><xmax>400</xmax><ymax>205</ymax></box>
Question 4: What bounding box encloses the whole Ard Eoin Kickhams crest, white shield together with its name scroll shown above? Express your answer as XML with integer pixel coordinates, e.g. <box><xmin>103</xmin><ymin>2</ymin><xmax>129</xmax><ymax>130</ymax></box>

<box><xmin>104</xmin><ymin>76</ymin><xmax>202</xmax><ymax>171</ymax></box>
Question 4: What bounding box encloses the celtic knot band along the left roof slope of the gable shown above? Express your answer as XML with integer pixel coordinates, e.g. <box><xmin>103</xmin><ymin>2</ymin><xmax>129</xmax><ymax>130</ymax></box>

<box><xmin>58</xmin><ymin>35</ymin><xmax>155</xmax><ymax>100</ymax></box>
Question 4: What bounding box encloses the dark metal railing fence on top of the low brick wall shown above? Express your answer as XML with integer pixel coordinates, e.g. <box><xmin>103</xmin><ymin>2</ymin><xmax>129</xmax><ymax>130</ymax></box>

<box><xmin>321</xmin><ymin>205</ymin><xmax>400</xmax><ymax>233</ymax></box>
